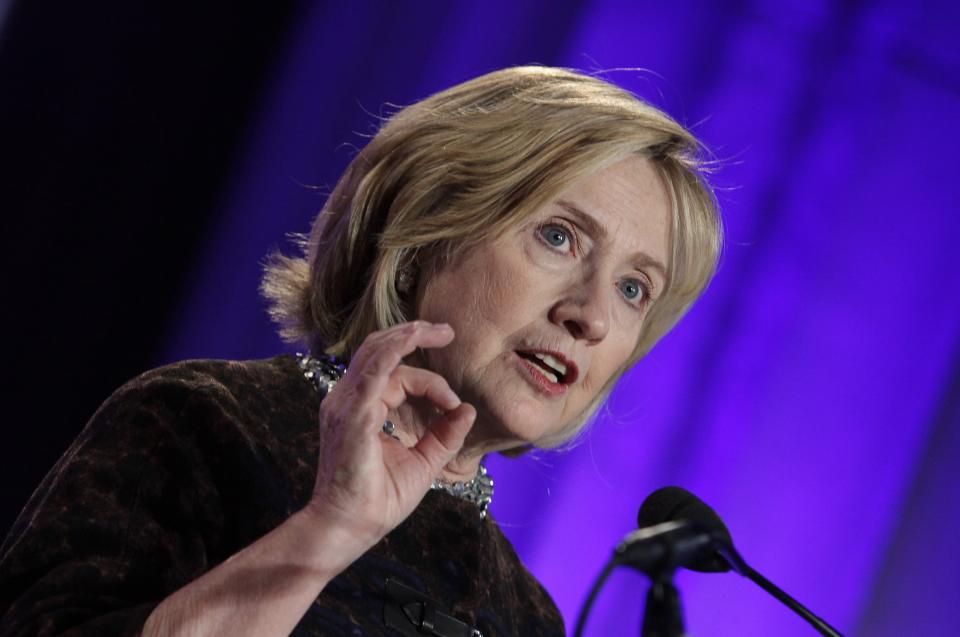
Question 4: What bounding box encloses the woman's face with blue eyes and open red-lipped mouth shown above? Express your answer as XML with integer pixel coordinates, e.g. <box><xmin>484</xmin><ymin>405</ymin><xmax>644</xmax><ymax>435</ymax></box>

<box><xmin>417</xmin><ymin>157</ymin><xmax>670</xmax><ymax>449</ymax></box>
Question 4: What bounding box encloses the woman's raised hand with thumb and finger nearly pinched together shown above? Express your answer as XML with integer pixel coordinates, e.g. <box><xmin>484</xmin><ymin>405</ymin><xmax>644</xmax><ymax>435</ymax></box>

<box><xmin>308</xmin><ymin>321</ymin><xmax>476</xmax><ymax>546</ymax></box>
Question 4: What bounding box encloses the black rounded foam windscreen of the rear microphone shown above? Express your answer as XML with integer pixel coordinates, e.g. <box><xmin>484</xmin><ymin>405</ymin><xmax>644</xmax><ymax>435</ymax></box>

<box><xmin>637</xmin><ymin>487</ymin><xmax>733</xmax><ymax>573</ymax></box>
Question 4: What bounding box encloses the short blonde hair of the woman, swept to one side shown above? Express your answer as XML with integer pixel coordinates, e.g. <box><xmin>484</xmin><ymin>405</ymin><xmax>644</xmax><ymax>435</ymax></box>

<box><xmin>261</xmin><ymin>66</ymin><xmax>722</xmax><ymax>444</ymax></box>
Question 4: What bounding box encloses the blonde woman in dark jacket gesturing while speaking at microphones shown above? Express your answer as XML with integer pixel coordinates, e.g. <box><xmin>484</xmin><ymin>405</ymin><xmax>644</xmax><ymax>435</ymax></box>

<box><xmin>0</xmin><ymin>67</ymin><xmax>720</xmax><ymax>637</ymax></box>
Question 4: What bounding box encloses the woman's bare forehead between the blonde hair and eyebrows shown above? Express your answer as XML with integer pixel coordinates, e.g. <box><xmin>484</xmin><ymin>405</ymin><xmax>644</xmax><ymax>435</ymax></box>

<box><xmin>554</xmin><ymin>157</ymin><xmax>671</xmax><ymax>264</ymax></box>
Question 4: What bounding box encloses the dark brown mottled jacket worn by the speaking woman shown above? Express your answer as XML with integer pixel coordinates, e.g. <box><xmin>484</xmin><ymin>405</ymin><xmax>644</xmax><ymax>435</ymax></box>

<box><xmin>0</xmin><ymin>356</ymin><xmax>563</xmax><ymax>637</ymax></box>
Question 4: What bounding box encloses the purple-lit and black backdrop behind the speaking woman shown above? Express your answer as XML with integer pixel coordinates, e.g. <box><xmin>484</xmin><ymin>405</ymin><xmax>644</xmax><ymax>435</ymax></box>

<box><xmin>0</xmin><ymin>0</ymin><xmax>960</xmax><ymax>637</ymax></box>
